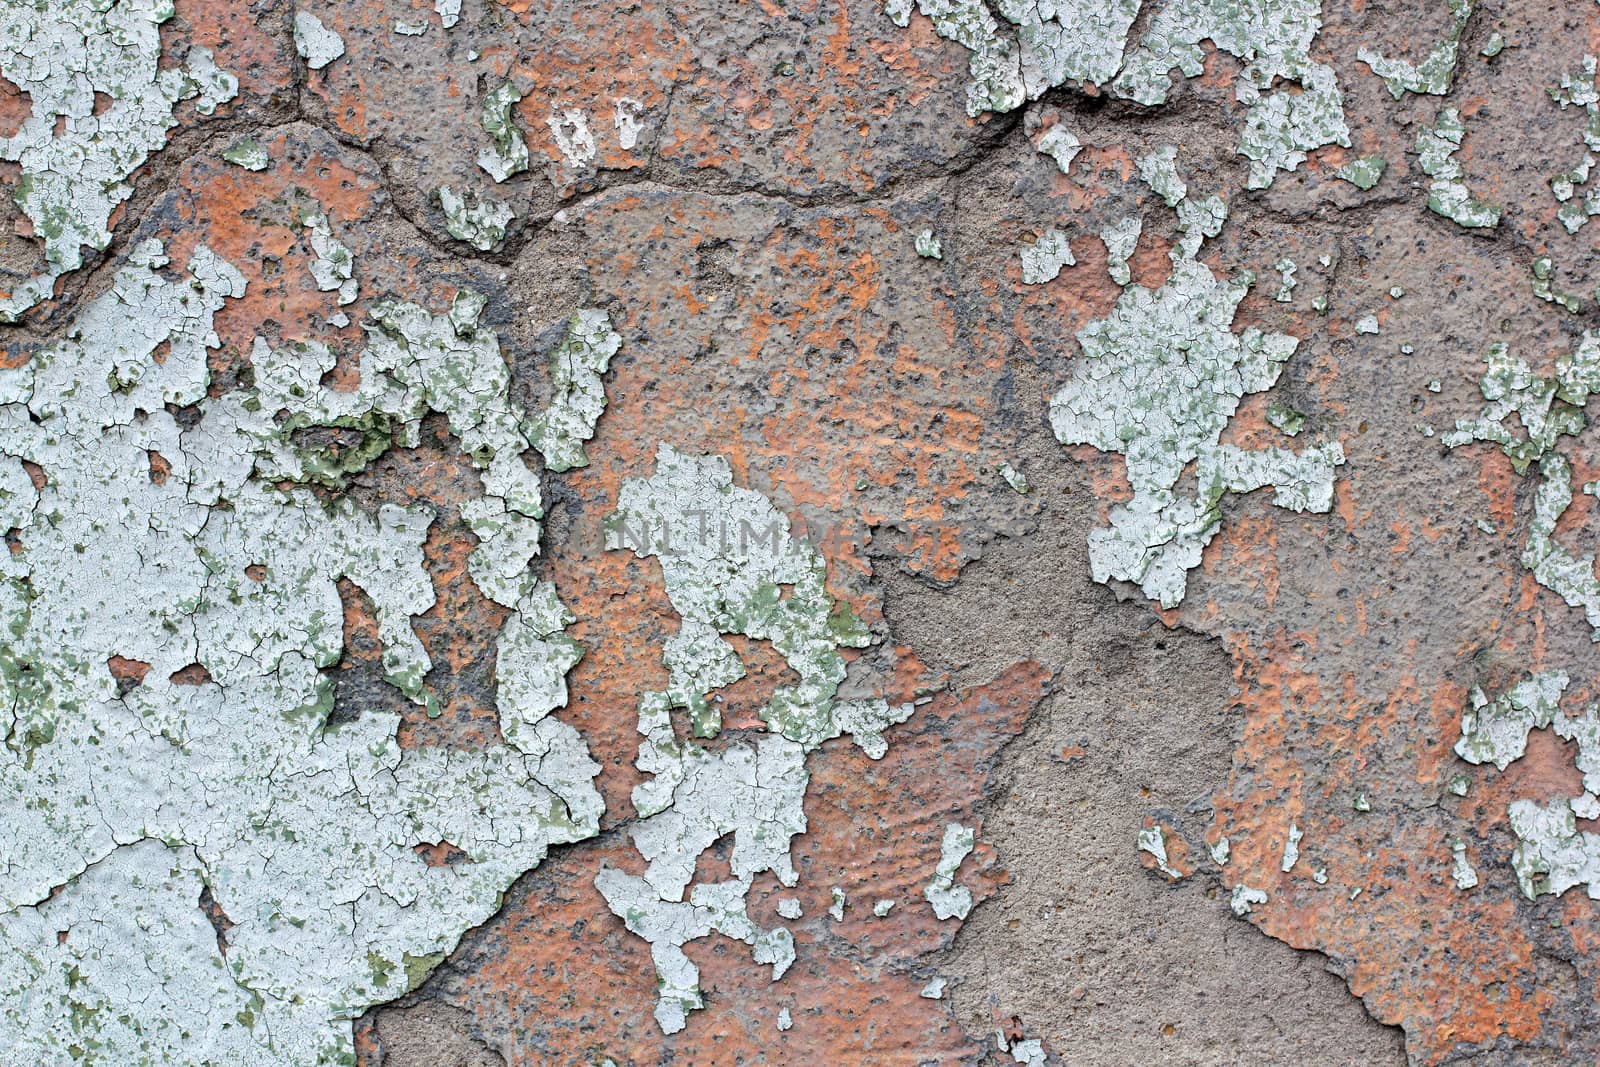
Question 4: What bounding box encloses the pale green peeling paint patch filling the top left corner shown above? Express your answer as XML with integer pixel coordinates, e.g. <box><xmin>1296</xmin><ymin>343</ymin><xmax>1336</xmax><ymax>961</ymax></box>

<box><xmin>0</xmin><ymin>0</ymin><xmax>238</xmax><ymax>323</ymax></box>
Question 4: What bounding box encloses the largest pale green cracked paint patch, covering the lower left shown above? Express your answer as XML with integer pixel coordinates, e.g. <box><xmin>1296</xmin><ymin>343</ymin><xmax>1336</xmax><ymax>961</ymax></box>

<box><xmin>0</xmin><ymin>242</ymin><xmax>602</xmax><ymax>1067</ymax></box>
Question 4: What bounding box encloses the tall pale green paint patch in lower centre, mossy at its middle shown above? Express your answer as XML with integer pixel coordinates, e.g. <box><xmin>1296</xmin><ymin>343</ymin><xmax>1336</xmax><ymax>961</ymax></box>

<box><xmin>595</xmin><ymin>445</ymin><xmax>912</xmax><ymax>1033</ymax></box>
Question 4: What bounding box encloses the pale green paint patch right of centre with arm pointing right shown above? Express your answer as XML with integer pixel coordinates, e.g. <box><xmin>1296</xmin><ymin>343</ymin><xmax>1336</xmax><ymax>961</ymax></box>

<box><xmin>1050</xmin><ymin>149</ymin><xmax>1344</xmax><ymax>608</ymax></box>
